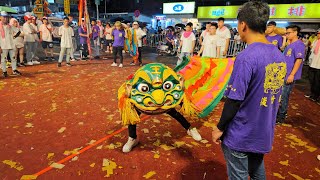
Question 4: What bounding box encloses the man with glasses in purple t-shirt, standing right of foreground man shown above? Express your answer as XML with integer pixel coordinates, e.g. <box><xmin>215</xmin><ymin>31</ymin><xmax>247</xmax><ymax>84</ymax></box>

<box><xmin>277</xmin><ymin>25</ymin><xmax>305</xmax><ymax>124</ymax></box>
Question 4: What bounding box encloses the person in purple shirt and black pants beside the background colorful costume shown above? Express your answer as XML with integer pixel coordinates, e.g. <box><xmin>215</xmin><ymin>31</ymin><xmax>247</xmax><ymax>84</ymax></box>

<box><xmin>111</xmin><ymin>21</ymin><xmax>127</xmax><ymax>68</ymax></box>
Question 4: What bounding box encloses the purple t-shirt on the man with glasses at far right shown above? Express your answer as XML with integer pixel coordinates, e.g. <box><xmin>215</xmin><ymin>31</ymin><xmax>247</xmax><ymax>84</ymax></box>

<box><xmin>283</xmin><ymin>40</ymin><xmax>305</xmax><ymax>80</ymax></box>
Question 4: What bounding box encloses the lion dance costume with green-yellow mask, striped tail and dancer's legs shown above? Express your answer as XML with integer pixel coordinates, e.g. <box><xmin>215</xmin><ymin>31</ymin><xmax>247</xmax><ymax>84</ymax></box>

<box><xmin>118</xmin><ymin>57</ymin><xmax>234</xmax><ymax>152</ymax></box>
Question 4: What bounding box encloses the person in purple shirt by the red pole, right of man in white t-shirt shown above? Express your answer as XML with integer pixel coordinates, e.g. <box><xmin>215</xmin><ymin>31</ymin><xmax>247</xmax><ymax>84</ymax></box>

<box><xmin>78</xmin><ymin>19</ymin><xmax>89</xmax><ymax>60</ymax></box>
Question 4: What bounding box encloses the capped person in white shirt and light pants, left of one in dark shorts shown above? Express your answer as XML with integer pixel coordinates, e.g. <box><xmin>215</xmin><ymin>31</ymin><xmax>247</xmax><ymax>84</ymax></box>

<box><xmin>22</xmin><ymin>15</ymin><xmax>40</xmax><ymax>66</ymax></box>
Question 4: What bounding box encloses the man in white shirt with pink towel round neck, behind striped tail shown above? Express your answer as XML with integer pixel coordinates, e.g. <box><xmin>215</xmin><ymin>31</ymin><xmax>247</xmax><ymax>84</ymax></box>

<box><xmin>177</xmin><ymin>22</ymin><xmax>196</xmax><ymax>65</ymax></box>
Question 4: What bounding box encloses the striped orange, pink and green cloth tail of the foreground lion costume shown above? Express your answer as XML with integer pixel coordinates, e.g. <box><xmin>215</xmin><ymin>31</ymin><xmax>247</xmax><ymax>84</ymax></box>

<box><xmin>175</xmin><ymin>57</ymin><xmax>234</xmax><ymax>117</ymax></box>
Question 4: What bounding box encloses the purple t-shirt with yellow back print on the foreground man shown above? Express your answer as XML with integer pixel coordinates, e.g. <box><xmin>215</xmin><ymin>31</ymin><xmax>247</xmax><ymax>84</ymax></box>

<box><xmin>223</xmin><ymin>43</ymin><xmax>287</xmax><ymax>153</ymax></box>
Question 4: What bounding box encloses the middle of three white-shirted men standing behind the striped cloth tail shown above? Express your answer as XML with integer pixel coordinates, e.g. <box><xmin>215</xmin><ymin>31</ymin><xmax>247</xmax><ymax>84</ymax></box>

<box><xmin>198</xmin><ymin>23</ymin><xmax>221</xmax><ymax>58</ymax></box>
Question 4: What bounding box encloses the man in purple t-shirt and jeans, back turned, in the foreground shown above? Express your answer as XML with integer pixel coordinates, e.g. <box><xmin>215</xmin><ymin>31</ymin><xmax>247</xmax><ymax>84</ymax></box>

<box><xmin>212</xmin><ymin>1</ymin><xmax>287</xmax><ymax>180</ymax></box>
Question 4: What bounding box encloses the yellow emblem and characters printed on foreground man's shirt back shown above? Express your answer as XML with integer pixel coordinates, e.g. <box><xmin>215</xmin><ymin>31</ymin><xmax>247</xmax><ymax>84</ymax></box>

<box><xmin>260</xmin><ymin>62</ymin><xmax>287</xmax><ymax>107</ymax></box>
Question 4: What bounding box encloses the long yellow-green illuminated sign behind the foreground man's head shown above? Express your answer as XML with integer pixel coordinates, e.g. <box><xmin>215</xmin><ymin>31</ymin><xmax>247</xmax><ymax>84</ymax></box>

<box><xmin>198</xmin><ymin>3</ymin><xmax>320</xmax><ymax>19</ymax></box>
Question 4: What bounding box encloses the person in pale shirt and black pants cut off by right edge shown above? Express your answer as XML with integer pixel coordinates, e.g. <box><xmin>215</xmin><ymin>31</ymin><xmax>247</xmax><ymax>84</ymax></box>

<box><xmin>305</xmin><ymin>29</ymin><xmax>320</xmax><ymax>105</ymax></box>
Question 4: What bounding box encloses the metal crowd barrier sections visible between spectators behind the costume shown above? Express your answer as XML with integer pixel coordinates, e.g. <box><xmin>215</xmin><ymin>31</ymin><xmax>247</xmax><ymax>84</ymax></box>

<box><xmin>146</xmin><ymin>34</ymin><xmax>247</xmax><ymax>57</ymax></box>
